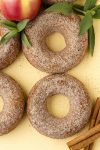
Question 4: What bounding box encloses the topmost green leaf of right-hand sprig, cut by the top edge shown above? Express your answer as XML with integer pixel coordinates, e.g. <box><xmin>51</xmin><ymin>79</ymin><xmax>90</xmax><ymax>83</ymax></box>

<box><xmin>84</xmin><ymin>0</ymin><xmax>97</xmax><ymax>11</ymax></box>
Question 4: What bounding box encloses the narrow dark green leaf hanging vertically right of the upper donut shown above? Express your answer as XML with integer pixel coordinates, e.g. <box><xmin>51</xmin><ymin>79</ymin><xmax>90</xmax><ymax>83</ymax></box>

<box><xmin>88</xmin><ymin>26</ymin><xmax>95</xmax><ymax>56</ymax></box>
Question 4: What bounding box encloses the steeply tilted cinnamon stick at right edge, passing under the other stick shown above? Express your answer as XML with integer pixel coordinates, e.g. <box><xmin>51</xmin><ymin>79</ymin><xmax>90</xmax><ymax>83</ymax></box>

<box><xmin>84</xmin><ymin>98</ymin><xmax>100</xmax><ymax>150</ymax></box>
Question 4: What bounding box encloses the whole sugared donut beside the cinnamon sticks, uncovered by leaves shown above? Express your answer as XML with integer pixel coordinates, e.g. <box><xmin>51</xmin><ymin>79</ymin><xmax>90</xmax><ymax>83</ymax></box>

<box><xmin>27</xmin><ymin>74</ymin><xmax>91</xmax><ymax>139</ymax></box>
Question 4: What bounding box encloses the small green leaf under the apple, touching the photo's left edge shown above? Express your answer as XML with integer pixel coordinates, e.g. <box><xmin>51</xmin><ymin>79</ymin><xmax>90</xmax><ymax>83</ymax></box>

<box><xmin>0</xmin><ymin>20</ymin><xmax>17</xmax><ymax>29</ymax></box>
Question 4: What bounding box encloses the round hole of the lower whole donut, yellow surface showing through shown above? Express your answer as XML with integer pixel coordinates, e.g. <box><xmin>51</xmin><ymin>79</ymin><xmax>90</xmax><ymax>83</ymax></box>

<box><xmin>47</xmin><ymin>94</ymin><xmax>70</xmax><ymax>118</ymax></box>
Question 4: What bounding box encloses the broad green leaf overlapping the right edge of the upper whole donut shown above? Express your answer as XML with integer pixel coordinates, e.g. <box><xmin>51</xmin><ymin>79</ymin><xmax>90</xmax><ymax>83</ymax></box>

<box><xmin>80</xmin><ymin>12</ymin><xmax>93</xmax><ymax>34</ymax></box>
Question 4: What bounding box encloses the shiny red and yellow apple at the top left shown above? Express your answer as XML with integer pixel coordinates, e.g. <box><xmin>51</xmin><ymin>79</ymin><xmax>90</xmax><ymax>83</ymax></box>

<box><xmin>0</xmin><ymin>0</ymin><xmax>41</xmax><ymax>21</ymax></box>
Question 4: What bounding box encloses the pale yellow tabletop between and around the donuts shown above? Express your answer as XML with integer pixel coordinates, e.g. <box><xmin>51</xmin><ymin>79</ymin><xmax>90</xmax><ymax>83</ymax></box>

<box><xmin>0</xmin><ymin>0</ymin><xmax>100</xmax><ymax>150</ymax></box>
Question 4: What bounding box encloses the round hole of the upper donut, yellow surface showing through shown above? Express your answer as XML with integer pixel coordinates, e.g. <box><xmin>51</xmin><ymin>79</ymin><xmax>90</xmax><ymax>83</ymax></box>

<box><xmin>45</xmin><ymin>32</ymin><xmax>66</xmax><ymax>52</ymax></box>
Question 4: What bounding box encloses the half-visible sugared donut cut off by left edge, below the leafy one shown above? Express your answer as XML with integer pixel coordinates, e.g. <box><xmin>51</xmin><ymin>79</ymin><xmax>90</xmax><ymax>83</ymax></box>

<box><xmin>0</xmin><ymin>72</ymin><xmax>25</xmax><ymax>135</ymax></box>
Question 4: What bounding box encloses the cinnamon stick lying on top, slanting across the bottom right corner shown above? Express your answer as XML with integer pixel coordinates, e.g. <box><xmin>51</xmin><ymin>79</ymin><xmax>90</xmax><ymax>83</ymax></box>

<box><xmin>67</xmin><ymin>124</ymin><xmax>100</xmax><ymax>150</ymax></box>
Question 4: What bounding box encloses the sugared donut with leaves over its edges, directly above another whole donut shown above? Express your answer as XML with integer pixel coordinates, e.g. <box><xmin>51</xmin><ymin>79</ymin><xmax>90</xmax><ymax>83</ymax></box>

<box><xmin>23</xmin><ymin>12</ymin><xmax>88</xmax><ymax>74</ymax></box>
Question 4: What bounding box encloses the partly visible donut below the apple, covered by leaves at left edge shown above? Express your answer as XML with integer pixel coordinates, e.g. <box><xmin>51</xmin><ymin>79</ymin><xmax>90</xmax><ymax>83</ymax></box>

<box><xmin>0</xmin><ymin>14</ymin><xmax>21</xmax><ymax>69</ymax></box>
